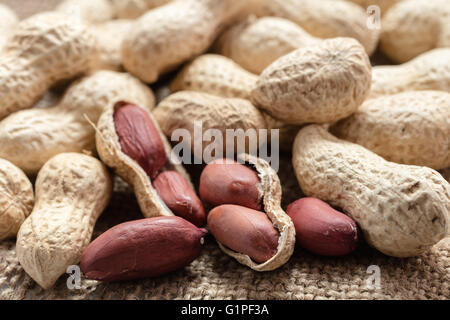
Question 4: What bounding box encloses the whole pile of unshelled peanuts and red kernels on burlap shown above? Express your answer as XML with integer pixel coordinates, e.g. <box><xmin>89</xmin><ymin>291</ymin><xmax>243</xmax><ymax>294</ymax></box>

<box><xmin>0</xmin><ymin>0</ymin><xmax>450</xmax><ymax>289</ymax></box>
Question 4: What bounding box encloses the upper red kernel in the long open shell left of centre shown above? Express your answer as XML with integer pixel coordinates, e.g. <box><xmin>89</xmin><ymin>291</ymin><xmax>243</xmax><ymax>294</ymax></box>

<box><xmin>114</xmin><ymin>104</ymin><xmax>167</xmax><ymax>179</ymax></box>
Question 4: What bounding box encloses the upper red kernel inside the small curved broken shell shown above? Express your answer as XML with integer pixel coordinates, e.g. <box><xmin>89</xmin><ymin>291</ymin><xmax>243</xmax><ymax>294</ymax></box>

<box><xmin>199</xmin><ymin>159</ymin><xmax>261</xmax><ymax>210</ymax></box>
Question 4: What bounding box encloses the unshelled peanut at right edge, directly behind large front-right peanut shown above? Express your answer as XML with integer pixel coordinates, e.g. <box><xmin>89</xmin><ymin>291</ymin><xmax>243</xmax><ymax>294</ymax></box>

<box><xmin>330</xmin><ymin>91</ymin><xmax>450</xmax><ymax>170</ymax></box>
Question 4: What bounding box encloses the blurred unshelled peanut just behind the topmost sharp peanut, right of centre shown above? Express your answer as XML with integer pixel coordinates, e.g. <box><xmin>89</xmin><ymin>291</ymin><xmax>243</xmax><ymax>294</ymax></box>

<box><xmin>214</xmin><ymin>16</ymin><xmax>321</xmax><ymax>74</ymax></box>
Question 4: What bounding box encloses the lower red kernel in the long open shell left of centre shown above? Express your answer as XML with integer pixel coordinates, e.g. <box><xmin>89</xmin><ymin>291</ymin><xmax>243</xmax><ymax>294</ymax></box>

<box><xmin>153</xmin><ymin>171</ymin><xmax>206</xmax><ymax>227</ymax></box>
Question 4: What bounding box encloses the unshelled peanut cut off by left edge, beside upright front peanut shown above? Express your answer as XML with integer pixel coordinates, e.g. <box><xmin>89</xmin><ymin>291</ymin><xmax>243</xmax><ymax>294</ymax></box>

<box><xmin>0</xmin><ymin>159</ymin><xmax>34</xmax><ymax>241</ymax></box>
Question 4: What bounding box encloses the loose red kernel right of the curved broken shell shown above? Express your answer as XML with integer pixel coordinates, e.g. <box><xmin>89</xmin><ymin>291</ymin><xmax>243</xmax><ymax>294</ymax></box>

<box><xmin>286</xmin><ymin>198</ymin><xmax>358</xmax><ymax>256</ymax></box>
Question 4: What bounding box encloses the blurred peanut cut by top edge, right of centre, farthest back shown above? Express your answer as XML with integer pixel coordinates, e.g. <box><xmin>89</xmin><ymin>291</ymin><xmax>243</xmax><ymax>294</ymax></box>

<box><xmin>254</xmin><ymin>0</ymin><xmax>380</xmax><ymax>55</ymax></box>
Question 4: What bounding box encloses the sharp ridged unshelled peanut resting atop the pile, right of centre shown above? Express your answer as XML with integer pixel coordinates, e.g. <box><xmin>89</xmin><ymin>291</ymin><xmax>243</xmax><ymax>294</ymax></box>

<box><xmin>252</xmin><ymin>38</ymin><xmax>371</xmax><ymax>124</ymax></box>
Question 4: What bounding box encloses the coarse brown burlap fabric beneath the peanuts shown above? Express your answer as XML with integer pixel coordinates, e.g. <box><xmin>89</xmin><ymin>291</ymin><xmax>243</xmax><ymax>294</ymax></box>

<box><xmin>0</xmin><ymin>0</ymin><xmax>450</xmax><ymax>299</ymax></box>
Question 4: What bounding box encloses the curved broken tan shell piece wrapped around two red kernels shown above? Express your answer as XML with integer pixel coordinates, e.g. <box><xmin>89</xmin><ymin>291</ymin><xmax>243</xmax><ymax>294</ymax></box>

<box><xmin>219</xmin><ymin>154</ymin><xmax>295</xmax><ymax>271</ymax></box>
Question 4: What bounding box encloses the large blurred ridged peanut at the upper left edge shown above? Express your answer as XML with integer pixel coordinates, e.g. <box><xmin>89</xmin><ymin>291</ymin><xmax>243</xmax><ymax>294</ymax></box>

<box><xmin>0</xmin><ymin>12</ymin><xmax>96</xmax><ymax>119</ymax></box>
